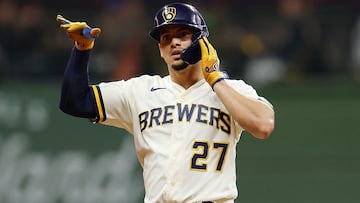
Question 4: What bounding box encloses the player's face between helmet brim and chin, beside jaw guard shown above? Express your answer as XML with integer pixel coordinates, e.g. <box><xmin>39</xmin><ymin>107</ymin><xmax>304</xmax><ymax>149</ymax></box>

<box><xmin>159</xmin><ymin>25</ymin><xmax>193</xmax><ymax>70</ymax></box>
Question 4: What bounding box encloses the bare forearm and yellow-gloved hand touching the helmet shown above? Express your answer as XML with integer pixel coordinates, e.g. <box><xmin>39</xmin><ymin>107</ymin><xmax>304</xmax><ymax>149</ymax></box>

<box><xmin>199</xmin><ymin>37</ymin><xmax>275</xmax><ymax>139</ymax></box>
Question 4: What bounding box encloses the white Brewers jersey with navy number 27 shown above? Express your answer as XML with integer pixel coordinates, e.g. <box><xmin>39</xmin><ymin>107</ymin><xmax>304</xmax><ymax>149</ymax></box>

<box><xmin>93</xmin><ymin>75</ymin><xmax>272</xmax><ymax>203</ymax></box>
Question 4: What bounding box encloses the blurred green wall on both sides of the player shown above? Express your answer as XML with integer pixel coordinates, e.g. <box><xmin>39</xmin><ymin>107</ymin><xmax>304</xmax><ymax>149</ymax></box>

<box><xmin>0</xmin><ymin>81</ymin><xmax>360</xmax><ymax>203</ymax></box>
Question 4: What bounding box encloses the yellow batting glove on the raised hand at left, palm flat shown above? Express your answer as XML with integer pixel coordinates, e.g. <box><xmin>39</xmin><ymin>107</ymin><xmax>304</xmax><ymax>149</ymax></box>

<box><xmin>56</xmin><ymin>15</ymin><xmax>101</xmax><ymax>50</ymax></box>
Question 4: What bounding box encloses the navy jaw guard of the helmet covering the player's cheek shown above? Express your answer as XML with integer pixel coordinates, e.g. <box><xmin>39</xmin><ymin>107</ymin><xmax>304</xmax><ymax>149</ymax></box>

<box><xmin>180</xmin><ymin>32</ymin><xmax>206</xmax><ymax>64</ymax></box>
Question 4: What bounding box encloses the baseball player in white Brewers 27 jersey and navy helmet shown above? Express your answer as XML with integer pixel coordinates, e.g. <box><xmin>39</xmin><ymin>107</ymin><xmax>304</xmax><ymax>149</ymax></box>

<box><xmin>57</xmin><ymin>3</ymin><xmax>274</xmax><ymax>203</ymax></box>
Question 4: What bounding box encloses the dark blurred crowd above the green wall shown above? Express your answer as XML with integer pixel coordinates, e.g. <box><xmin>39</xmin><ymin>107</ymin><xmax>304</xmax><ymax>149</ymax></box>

<box><xmin>0</xmin><ymin>0</ymin><xmax>360</xmax><ymax>84</ymax></box>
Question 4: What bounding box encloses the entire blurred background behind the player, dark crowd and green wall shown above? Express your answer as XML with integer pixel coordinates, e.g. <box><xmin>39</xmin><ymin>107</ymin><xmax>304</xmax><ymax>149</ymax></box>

<box><xmin>0</xmin><ymin>0</ymin><xmax>360</xmax><ymax>203</ymax></box>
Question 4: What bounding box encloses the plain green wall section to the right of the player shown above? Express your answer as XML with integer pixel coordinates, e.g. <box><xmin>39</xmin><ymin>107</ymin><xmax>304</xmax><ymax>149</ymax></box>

<box><xmin>238</xmin><ymin>81</ymin><xmax>360</xmax><ymax>203</ymax></box>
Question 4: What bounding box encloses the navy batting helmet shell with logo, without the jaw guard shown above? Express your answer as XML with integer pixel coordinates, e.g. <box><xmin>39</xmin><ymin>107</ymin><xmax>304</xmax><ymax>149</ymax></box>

<box><xmin>149</xmin><ymin>3</ymin><xmax>209</xmax><ymax>41</ymax></box>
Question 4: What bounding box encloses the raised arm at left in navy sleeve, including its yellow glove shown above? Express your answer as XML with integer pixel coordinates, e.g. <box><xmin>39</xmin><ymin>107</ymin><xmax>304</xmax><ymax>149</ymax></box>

<box><xmin>56</xmin><ymin>15</ymin><xmax>101</xmax><ymax>119</ymax></box>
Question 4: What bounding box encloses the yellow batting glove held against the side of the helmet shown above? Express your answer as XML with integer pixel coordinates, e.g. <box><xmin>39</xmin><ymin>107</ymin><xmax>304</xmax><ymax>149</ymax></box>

<box><xmin>199</xmin><ymin>36</ymin><xmax>228</xmax><ymax>88</ymax></box>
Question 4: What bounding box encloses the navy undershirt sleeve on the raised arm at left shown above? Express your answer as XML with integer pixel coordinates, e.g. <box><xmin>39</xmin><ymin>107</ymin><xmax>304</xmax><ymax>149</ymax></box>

<box><xmin>59</xmin><ymin>47</ymin><xmax>97</xmax><ymax>119</ymax></box>
